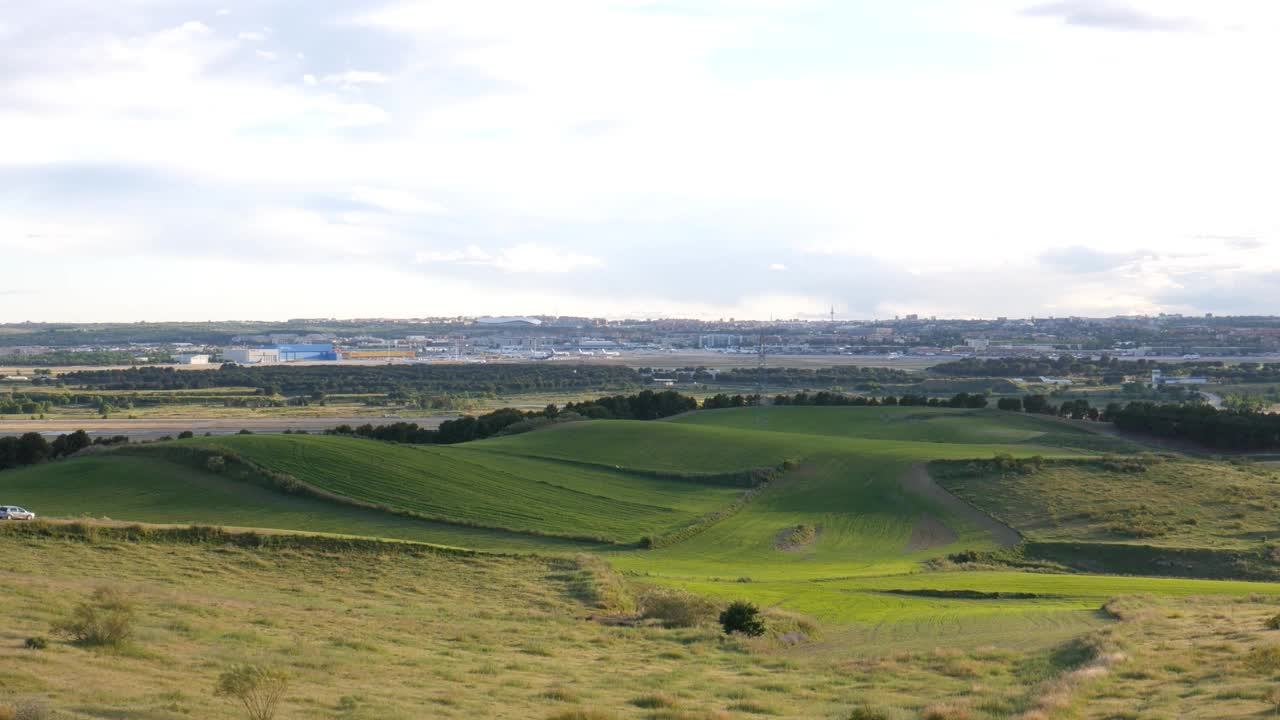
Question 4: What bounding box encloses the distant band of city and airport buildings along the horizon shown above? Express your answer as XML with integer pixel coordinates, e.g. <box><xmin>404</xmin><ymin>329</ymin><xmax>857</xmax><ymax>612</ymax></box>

<box><xmin>0</xmin><ymin>314</ymin><xmax>1280</xmax><ymax>366</ymax></box>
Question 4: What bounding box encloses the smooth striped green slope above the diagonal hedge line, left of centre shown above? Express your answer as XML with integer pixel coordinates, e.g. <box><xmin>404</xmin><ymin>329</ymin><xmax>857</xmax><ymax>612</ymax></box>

<box><xmin>179</xmin><ymin>436</ymin><xmax>741</xmax><ymax>543</ymax></box>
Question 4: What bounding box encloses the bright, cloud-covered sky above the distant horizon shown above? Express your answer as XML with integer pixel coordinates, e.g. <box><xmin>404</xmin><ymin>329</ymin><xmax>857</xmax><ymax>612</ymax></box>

<box><xmin>0</xmin><ymin>0</ymin><xmax>1280</xmax><ymax>322</ymax></box>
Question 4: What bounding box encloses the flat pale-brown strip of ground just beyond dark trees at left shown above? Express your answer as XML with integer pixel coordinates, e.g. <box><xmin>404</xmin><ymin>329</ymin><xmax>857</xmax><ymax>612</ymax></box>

<box><xmin>0</xmin><ymin>415</ymin><xmax>457</xmax><ymax>439</ymax></box>
